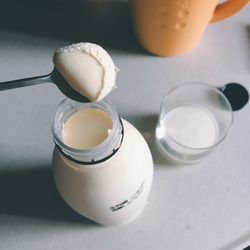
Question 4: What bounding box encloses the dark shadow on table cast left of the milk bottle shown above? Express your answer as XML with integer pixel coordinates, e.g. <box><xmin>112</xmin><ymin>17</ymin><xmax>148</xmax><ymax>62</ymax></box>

<box><xmin>0</xmin><ymin>167</ymin><xmax>97</xmax><ymax>226</ymax></box>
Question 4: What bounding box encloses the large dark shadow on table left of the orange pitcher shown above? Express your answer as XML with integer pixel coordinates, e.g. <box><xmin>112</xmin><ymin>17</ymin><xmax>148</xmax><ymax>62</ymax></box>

<box><xmin>0</xmin><ymin>0</ymin><xmax>146</xmax><ymax>53</ymax></box>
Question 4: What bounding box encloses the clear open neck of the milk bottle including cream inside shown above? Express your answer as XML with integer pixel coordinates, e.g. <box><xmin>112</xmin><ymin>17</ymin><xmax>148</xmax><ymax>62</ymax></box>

<box><xmin>52</xmin><ymin>99</ymin><xmax>123</xmax><ymax>164</ymax></box>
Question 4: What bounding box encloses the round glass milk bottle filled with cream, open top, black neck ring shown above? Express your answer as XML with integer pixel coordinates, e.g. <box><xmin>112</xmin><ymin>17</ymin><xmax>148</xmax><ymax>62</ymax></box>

<box><xmin>52</xmin><ymin>99</ymin><xmax>153</xmax><ymax>225</ymax></box>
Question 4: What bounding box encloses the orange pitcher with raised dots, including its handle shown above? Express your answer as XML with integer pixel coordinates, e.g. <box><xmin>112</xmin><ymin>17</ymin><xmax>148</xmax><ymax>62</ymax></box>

<box><xmin>130</xmin><ymin>0</ymin><xmax>249</xmax><ymax>56</ymax></box>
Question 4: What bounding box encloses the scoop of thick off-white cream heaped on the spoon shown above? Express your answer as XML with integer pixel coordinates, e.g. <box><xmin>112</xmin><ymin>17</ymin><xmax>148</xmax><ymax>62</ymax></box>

<box><xmin>53</xmin><ymin>43</ymin><xmax>118</xmax><ymax>102</ymax></box>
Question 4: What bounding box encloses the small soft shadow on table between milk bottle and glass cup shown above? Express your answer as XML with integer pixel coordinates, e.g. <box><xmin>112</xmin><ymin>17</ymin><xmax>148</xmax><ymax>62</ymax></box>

<box><xmin>126</xmin><ymin>114</ymin><xmax>180</xmax><ymax>167</ymax></box>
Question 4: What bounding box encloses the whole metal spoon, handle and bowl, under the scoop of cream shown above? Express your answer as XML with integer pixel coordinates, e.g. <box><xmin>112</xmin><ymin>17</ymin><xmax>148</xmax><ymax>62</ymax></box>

<box><xmin>0</xmin><ymin>68</ymin><xmax>90</xmax><ymax>102</ymax></box>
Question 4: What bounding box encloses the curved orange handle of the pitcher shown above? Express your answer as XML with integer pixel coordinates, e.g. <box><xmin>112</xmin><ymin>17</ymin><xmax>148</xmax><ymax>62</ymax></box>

<box><xmin>210</xmin><ymin>0</ymin><xmax>250</xmax><ymax>23</ymax></box>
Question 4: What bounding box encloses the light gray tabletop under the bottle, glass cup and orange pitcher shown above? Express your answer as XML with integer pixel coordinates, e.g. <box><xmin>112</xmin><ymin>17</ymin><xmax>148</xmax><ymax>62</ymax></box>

<box><xmin>0</xmin><ymin>0</ymin><xmax>250</xmax><ymax>250</ymax></box>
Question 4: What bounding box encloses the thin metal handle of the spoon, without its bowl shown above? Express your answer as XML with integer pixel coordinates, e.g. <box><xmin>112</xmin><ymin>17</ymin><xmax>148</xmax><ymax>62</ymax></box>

<box><xmin>0</xmin><ymin>74</ymin><xmax>51</xmax><ymax>91</ymax></box>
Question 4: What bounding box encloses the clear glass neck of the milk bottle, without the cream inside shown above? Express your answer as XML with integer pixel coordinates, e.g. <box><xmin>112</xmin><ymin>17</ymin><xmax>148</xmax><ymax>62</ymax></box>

<box><xmin>52</xmin><ymin>99</ymin><xmax>123</xmax><ymax>165</ymax></box>
